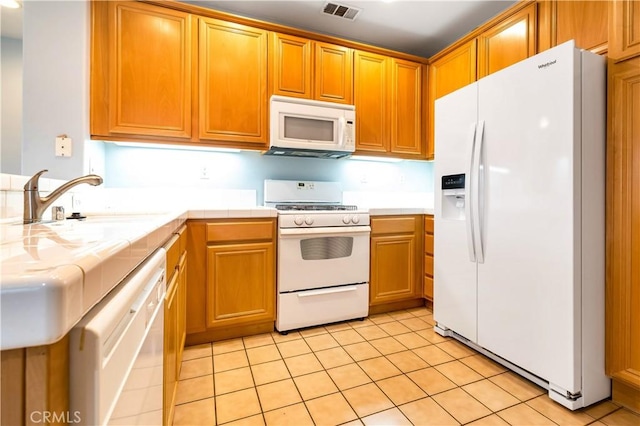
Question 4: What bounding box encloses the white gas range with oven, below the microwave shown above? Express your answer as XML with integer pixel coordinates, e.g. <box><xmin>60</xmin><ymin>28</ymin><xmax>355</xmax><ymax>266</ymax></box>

<box><xmin>264</xmin><ymin>180</ymin><xmax>371</xmax><ymax>333</ymax></box>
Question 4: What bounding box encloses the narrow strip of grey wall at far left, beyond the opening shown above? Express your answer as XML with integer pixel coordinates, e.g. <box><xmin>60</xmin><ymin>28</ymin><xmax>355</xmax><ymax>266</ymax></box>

<box><xmin>0</xmin><ymin>37</ymin><xmax>22</xmax><ymax>174</ymax></box>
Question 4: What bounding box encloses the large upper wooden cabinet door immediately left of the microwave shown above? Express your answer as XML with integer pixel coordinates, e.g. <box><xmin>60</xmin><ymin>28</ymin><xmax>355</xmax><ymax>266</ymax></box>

<box><xmin>199</xmin><ymin>18</ymin><xmax>268</xmax><ymax>146</ymax></box>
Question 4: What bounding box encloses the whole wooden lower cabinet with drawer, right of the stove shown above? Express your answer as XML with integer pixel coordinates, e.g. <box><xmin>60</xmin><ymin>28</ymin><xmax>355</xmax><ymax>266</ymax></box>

<box><xmin>369</xmin><ymin>215</ymin><xmax>424</xmax><ymax>313</ymax></box>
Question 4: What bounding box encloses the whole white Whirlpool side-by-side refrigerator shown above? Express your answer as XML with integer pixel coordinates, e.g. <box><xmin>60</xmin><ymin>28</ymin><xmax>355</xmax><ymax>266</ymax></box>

<box><xmin>434</xmin><ymin>41</ymin><xmax>610</xmax><ymax>409</ymax></box>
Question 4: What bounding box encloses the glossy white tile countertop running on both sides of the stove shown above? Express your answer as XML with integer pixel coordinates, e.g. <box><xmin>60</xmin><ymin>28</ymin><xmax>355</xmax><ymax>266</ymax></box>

<box><xmin>0</xmin><ymin>207</ymin><xmax>433</xmax><ymax>350</ymax></box>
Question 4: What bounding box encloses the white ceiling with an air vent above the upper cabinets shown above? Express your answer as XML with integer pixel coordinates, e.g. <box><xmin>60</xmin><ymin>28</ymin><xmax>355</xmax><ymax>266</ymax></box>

<box><xmin>185</xmin><ymin>0</ymin><xmax>515</xmax><ymax>57</ymax></box>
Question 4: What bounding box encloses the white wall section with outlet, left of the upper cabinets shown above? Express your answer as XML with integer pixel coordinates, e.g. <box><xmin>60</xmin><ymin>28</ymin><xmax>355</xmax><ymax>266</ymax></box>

<box><xmin>22</xmin><ymin>0</ymin><xmax>91</xmax><ymax>179</ymax></box>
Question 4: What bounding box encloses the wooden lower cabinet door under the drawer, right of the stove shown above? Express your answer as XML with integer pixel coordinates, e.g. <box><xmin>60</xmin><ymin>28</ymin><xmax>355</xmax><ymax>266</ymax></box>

<box><xmin>369</xmin><ymin>234</ymin><xmax>419</xmax><ymax>305</ymax></box>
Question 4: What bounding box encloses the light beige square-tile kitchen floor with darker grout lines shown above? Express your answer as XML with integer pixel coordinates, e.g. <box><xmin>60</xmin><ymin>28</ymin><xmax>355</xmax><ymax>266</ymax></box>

<box><xmin>174</xmin><ymin>308</ymin><xmax>640</xmax><ymax>426</ymax></box>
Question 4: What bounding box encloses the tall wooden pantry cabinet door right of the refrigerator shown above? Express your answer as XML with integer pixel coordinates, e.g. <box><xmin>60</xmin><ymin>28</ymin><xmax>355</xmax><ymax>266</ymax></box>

<box><xmin>605</xmin><ymin>56</ymin><xmax>640</xmax><ymax>410</ymax></box>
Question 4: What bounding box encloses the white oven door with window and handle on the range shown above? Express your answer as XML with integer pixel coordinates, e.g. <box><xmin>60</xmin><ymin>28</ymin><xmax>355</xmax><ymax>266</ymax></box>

<box><xmin>277</xmin><ymin>226</ymin><xmax>371</xmax><ymax>293</ymax></box>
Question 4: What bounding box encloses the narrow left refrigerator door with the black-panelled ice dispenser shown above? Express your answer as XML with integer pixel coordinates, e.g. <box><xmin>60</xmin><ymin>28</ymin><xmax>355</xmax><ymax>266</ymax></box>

<box><xmin>433</xmin><ymin>84</ymin><xmax>478</xmax><ymax>342</ymax></box>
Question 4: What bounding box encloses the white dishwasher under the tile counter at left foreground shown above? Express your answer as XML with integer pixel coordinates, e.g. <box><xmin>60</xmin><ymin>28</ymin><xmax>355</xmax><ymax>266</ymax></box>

<box><xmin>69</xmin><ymin>248</ymin><xmax>166</xmax><ymax>425</ymax></box>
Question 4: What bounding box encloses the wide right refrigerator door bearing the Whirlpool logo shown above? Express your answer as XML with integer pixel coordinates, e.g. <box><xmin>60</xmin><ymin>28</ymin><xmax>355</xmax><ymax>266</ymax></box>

<box><xmin>478</xmin><ymin>43</ymin><xmax>581</xmax><ymax>392</ymax></box>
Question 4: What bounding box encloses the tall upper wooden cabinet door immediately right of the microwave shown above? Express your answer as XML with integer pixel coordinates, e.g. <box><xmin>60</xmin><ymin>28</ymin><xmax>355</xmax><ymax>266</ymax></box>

<box><xmin>354</xmin><ymin>51</ymin><xmax>390</xmax><ymax>152</ymax></box>
